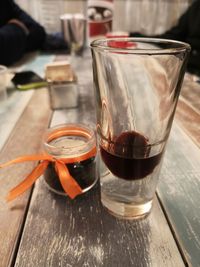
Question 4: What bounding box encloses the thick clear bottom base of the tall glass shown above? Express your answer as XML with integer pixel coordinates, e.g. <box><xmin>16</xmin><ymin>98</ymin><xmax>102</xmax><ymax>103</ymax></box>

<box><xmin>101</xmin><ymin>193</ymin><xmax>153</xmax><ymax>220</ymax></box>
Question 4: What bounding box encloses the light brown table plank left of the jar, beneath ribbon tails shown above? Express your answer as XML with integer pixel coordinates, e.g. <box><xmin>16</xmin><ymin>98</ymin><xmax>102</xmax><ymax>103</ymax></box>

<box><xmin>0</xmin><ymin>89</ymin><xmax>51</xmax><ymax>267</ymax></box>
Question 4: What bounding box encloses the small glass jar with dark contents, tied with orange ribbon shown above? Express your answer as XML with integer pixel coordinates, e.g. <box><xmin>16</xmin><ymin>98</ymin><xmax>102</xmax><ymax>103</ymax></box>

<box><xmin>43</xmin><ymin>124</ymin><xmax>98</xmax><ymax>195</ymax></box>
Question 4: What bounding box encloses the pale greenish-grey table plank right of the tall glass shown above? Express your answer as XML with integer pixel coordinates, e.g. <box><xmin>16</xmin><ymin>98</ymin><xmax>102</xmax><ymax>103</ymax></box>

<box><xmin>157</xmin><ymin>124</ymin><xmax>200</xmax><ymax>267</ymax></box>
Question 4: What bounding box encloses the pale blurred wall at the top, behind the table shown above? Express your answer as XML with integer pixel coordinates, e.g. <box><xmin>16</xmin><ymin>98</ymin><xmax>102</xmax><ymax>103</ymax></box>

<box><xmin>16</xmin><ymin>0</ymin><xmax>193</xmax><ymax>34</ymax></box>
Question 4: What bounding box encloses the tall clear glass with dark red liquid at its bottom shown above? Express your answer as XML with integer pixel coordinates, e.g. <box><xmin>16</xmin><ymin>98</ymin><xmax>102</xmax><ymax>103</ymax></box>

<box><xmin>91</xmin><ymin>38</ymin><xmax>190</xmax><ymax>219</ymax></box>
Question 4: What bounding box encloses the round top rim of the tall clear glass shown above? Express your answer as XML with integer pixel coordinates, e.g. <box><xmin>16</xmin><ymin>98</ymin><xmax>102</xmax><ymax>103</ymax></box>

<box><xmin>90</xmin><ymin>37</ymin><xmax>191</xmax><ymax>55</ymax></box>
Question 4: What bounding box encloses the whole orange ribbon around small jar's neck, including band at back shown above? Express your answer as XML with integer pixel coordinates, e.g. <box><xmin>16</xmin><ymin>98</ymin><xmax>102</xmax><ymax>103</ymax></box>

<box><xmin>0</xmin><ymin>125</ymin><xmax>96</xmax><ymax>201</ymax></box>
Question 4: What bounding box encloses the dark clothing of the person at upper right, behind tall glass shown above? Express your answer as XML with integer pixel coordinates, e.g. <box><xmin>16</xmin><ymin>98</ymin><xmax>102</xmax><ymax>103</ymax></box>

<box><xmin>130</xmin><ymin>0</ymin><xmax>200</xmax><ymax>73</ymax></box>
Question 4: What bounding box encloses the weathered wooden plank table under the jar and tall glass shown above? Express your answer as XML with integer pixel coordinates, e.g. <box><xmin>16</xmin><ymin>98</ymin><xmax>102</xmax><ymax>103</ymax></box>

<box><xmin>0</xmin><ymin>55</ymin><xmax>200</xmax><ymax>267</ymax></box>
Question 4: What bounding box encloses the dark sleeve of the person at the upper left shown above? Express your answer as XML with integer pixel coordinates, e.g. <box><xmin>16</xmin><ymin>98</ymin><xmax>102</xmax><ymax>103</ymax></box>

<box><xmin>0</xmin><ymin>0</ymin><xmax>46</xmax><ymax>65</ymax></box>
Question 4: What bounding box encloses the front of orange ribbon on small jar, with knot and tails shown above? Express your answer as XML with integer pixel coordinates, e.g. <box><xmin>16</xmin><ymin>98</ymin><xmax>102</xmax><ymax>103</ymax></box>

<box><xmin>0</xmin><ymin>147</ymin><xmax>96</xmax><ymax>201</ymax></box>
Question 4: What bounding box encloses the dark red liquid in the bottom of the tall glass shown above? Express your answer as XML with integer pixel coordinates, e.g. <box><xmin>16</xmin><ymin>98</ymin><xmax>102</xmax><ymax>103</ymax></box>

<box><xmin>100</xmin><ymin>131</ymin><xmax>162</xmax><ymax>180</ymax></box>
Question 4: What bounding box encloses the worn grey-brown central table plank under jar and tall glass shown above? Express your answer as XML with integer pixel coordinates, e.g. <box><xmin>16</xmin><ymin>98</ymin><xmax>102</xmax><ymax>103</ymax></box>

<box><xmin>12</xmin><ymin>55</ymin><xmax>185</xmax><ymax>267</ymax></box>
